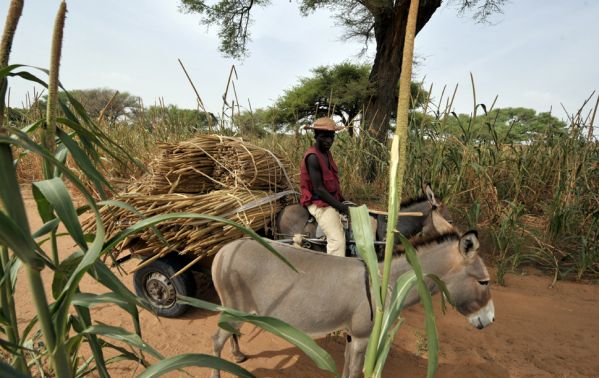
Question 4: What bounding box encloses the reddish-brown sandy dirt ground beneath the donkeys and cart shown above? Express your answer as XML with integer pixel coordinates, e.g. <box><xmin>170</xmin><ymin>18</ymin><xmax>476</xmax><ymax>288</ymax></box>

<box><xmin>16</xmin><ymin>188</ymin><xmax>599</xmax><ymax>378</ymax></box>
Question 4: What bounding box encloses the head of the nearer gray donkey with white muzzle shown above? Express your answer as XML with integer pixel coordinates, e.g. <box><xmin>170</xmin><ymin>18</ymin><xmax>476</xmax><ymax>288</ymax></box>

<box><xmin>439</xmin><ymin>231</ymin><xmax>495</xmax><ymax>329</ymax></box>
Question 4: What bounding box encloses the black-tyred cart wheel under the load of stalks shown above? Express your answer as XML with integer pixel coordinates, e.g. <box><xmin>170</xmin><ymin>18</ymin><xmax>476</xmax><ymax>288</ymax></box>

<box><xmin>133</xmin><ymin>255</ymin><xmax>196</xmax><ymax>318</ymax></box>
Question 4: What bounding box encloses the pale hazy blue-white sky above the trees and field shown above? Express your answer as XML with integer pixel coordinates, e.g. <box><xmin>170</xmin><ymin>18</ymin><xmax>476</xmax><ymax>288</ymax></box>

<box><xmin>0</xmin><ymin>0</ymin><xmax>599</xmax><ymax>118</ymax></box>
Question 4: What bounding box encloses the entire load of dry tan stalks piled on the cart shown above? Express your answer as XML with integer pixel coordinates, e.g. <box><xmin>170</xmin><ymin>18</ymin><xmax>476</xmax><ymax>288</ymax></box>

<box><xmin>86</xmin><ymin>135</ymin><xmax>292</xmax><ymax>273</ymax></box>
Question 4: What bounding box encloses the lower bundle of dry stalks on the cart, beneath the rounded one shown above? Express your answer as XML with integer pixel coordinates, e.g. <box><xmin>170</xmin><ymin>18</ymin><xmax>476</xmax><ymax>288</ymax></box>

<box><xmin>85</xmin><ymin>189</ymin><xmax>285</xmax><ymax>258</ymax></box>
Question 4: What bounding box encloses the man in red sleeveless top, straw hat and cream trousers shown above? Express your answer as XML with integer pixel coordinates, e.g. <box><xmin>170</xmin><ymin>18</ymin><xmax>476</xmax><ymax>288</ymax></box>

<box><xmin>300</xmin><ymin>117</ymin><xmax>349</xmax><ymax>256</ymax></box>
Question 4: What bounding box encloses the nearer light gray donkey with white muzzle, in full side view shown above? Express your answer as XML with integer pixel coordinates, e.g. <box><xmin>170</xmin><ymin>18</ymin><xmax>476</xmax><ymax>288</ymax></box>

<box><xmin>212</xmin><ymin>231</ymin><xmax>495</xmax><ymax>377</ymax></box>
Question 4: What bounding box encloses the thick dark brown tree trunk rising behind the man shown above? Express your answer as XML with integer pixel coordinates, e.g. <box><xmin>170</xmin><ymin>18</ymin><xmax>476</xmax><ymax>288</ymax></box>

<box><xmin>364</xmin><ymin>0</ymin><xmax>441</xmax><ymax>144</ymax></box>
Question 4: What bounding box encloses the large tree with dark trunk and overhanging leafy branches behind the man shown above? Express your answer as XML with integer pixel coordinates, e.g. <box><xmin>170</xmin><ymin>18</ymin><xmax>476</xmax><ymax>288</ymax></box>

<box><xmin>181</xmin><ymin>0</ymin><xmax>505</xmax><ymax>142</ymax></box>
